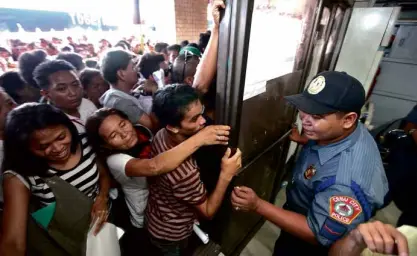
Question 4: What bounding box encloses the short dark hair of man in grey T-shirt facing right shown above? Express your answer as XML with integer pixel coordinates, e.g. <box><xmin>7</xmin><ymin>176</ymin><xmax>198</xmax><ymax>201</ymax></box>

<box><xmin>101</xmin><ymin>50</ymin><xmax>132</xmax><ymax>84</ymax></box>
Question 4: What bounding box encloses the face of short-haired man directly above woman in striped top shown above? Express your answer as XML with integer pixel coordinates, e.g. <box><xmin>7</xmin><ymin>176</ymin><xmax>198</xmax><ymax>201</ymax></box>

<box><xmin>46</xmin><ymin>71</ymin><xmax>83</xmax><ymax>110</ymax></box>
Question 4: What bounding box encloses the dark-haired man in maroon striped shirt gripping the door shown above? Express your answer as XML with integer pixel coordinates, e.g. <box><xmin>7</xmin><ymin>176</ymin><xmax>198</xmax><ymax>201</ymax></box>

<box><xmin>146</xmin><ymin>84</ymin><xmax>241</xmax><ymax>255</ymax></box>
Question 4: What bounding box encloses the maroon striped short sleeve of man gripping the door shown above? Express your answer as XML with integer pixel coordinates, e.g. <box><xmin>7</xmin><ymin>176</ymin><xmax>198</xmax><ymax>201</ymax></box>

<box><xmin>172</xmin><ymin>170</ymin><xmax>207</xmax><ymax>205</ymax></box>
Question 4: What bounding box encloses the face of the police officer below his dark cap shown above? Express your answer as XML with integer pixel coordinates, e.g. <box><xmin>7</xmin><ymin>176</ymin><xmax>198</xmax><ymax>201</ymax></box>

<box><xmin>300</xmin><ymin>111</ymin><xmax>344</xmax><ymax>142</ymax></box>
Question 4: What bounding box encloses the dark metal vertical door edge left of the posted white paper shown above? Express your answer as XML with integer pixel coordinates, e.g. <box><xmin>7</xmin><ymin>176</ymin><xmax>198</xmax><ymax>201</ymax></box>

<box><xmin>216</xmin><ymin>0</ymin><xmax>254</xmax><ymax>147</ymax></box>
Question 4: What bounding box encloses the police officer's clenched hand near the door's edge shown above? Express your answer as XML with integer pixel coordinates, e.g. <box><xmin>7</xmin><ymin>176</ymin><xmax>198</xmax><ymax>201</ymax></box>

<box><xmin>232</xmin><ymin>187</ymin><xmax>260</xmax><ymax>212</ymax></box>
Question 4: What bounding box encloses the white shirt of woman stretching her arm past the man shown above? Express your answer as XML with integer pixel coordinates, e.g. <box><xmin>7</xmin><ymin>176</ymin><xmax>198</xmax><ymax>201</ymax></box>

<box><xmin>107</xmin><ymin>154</ymin><xmax>149</xmax><ymax>228</ymax></box>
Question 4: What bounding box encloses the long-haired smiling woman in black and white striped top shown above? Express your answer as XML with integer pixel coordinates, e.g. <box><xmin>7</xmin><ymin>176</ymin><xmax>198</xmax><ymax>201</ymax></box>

<box><xmin>0</xmin><ymin>103</ymin><xmax>110</xmax><ymax>255</ymax></box>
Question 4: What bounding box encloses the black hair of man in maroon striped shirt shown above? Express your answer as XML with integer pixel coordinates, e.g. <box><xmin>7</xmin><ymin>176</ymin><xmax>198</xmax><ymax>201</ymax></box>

<box><xmin>152</xmin><ymin>84</ymin><xmax>200</xmax><ymax>127</ymax></box>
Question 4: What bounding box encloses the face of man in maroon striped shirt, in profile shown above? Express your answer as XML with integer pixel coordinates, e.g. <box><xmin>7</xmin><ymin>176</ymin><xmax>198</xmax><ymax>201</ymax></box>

<box><xmin>178</xmin><ymin>100</ymin><xmax>206</xmax><ymax>138</ymax></box>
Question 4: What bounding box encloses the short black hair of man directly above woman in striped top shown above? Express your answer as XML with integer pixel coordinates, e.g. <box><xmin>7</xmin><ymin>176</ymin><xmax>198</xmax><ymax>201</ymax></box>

<box><xmin>33</xmin><ymin>60</ymin><xmax>76</xmax><ymax>90</ymax></box>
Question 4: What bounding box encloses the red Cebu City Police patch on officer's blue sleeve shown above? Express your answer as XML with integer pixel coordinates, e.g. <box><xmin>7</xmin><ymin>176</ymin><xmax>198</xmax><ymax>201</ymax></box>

<box><xmin>329</xmin><ymin>196</ymin><xmax>362</xmax><ymax>225</ymax></box>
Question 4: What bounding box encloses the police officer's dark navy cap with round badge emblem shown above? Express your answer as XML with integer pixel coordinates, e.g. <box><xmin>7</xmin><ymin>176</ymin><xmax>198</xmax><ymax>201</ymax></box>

<box><xmin>285</xmin><ymin>71</ymin><xmax>365</xmax><ymax>115</ymax></box>
